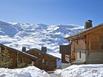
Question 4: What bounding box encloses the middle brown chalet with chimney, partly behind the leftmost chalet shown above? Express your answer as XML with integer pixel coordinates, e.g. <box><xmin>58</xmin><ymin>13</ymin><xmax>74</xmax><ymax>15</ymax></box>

<box><xmin>27</xmin><ymin>47</ymin><xmax>60</xmax><ymax>71</ymax></box>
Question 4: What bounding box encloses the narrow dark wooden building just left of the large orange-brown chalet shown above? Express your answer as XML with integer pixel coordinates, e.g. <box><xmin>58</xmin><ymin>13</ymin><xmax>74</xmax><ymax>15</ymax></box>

<box><xmin>59</xmin><ymin>44</ymin><xmax>71</xmax><ymax>68</ymax></box>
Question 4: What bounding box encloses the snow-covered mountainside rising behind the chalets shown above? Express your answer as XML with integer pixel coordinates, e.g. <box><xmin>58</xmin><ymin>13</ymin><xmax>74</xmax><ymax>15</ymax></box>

<box><xmin>0</xmin><ymin>21</ymin><xmax>83</xmax><ymax>52</ymax></box>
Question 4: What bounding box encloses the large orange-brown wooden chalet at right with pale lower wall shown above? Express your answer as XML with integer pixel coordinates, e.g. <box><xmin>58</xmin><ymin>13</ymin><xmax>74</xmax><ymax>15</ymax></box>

<box><xmin>67</xmin><ymin>20</ymin><xmax>103</xmax><ymax>64</ymax></box>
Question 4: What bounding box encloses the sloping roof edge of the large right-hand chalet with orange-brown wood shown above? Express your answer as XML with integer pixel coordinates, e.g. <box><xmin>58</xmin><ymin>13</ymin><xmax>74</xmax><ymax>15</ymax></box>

<box><xmin>66</xmin><ymin>24</ymin><xmax>103</xmax><ymax>40</ymax></box>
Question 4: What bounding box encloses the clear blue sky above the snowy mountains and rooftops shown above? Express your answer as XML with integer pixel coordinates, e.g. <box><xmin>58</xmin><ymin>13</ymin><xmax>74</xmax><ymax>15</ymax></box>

<box><xmin>0</xmin><ymin>0</ymin><xmax>103</xmax><ymax>25</ymax></box>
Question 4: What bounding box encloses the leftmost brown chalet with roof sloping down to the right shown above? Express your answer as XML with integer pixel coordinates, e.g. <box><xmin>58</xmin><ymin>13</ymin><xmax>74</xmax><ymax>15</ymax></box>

<box><xmin>0</xmin><ymin>44</ymin><xmax>37</xmax><ymax>68</ymax></box>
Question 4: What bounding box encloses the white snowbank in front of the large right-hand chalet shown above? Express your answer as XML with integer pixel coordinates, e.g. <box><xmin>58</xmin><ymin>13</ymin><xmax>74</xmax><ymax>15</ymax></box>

<box><xmin>61</xmin><ymin>64</ymin><xmax>103</xmax><ymax>77</ymax></box>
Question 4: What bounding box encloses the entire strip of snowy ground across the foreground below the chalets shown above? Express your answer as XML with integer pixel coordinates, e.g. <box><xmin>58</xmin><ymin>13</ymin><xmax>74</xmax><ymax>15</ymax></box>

<box><xmin>0</xmin><ymin>64</ymin><xmax>103</xmax><ymax>77</ymax></box>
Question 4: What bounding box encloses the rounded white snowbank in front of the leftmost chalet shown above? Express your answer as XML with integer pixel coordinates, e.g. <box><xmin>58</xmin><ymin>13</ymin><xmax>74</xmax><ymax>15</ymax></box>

<box><xmin>0</xmin><ymin>66</ymin><xmax>49</xmax><ymax>77</ymax></box>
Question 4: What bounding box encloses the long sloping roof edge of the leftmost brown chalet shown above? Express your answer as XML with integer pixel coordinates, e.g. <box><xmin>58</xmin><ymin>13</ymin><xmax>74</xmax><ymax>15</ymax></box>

<box><xmin>0</xmin><ymin>44</ymin><xmax>37</xmax><ymax>60</ymax></box>
